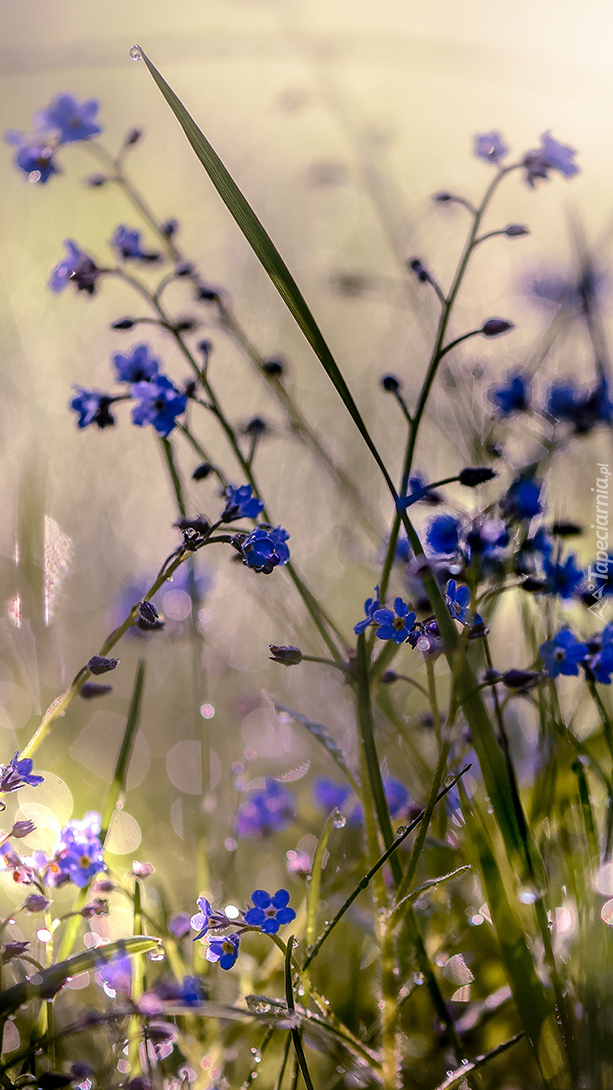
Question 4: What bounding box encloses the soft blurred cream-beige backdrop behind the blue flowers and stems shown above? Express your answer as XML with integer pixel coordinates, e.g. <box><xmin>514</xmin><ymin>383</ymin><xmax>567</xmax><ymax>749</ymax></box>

<box><xmin>0</xmin><ymin>0</ymin><xmax>613</xmax><ymax>919</ymax></box>
